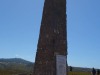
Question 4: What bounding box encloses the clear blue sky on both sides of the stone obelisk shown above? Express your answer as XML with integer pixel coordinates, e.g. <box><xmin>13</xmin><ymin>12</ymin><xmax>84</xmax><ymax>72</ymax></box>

<box><xmin>0</xmin><ymin>0</ymin><xmax>100</xmax><ymax>68</ymax></box>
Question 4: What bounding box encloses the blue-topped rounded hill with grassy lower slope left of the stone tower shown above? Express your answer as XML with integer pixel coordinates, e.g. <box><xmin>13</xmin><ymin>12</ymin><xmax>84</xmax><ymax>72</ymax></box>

<box><xmin>0</xmin><ymin>58</ymin><xmax>34</xmax><ymax>75</ymax></box>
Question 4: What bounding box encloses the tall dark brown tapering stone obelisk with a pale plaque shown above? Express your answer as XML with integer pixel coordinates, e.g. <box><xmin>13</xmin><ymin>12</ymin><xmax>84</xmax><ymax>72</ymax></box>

<box><xmin>33</xmin><ymin>0</ymin><xmax>67</xmax><ymax>75</ymax></box>
